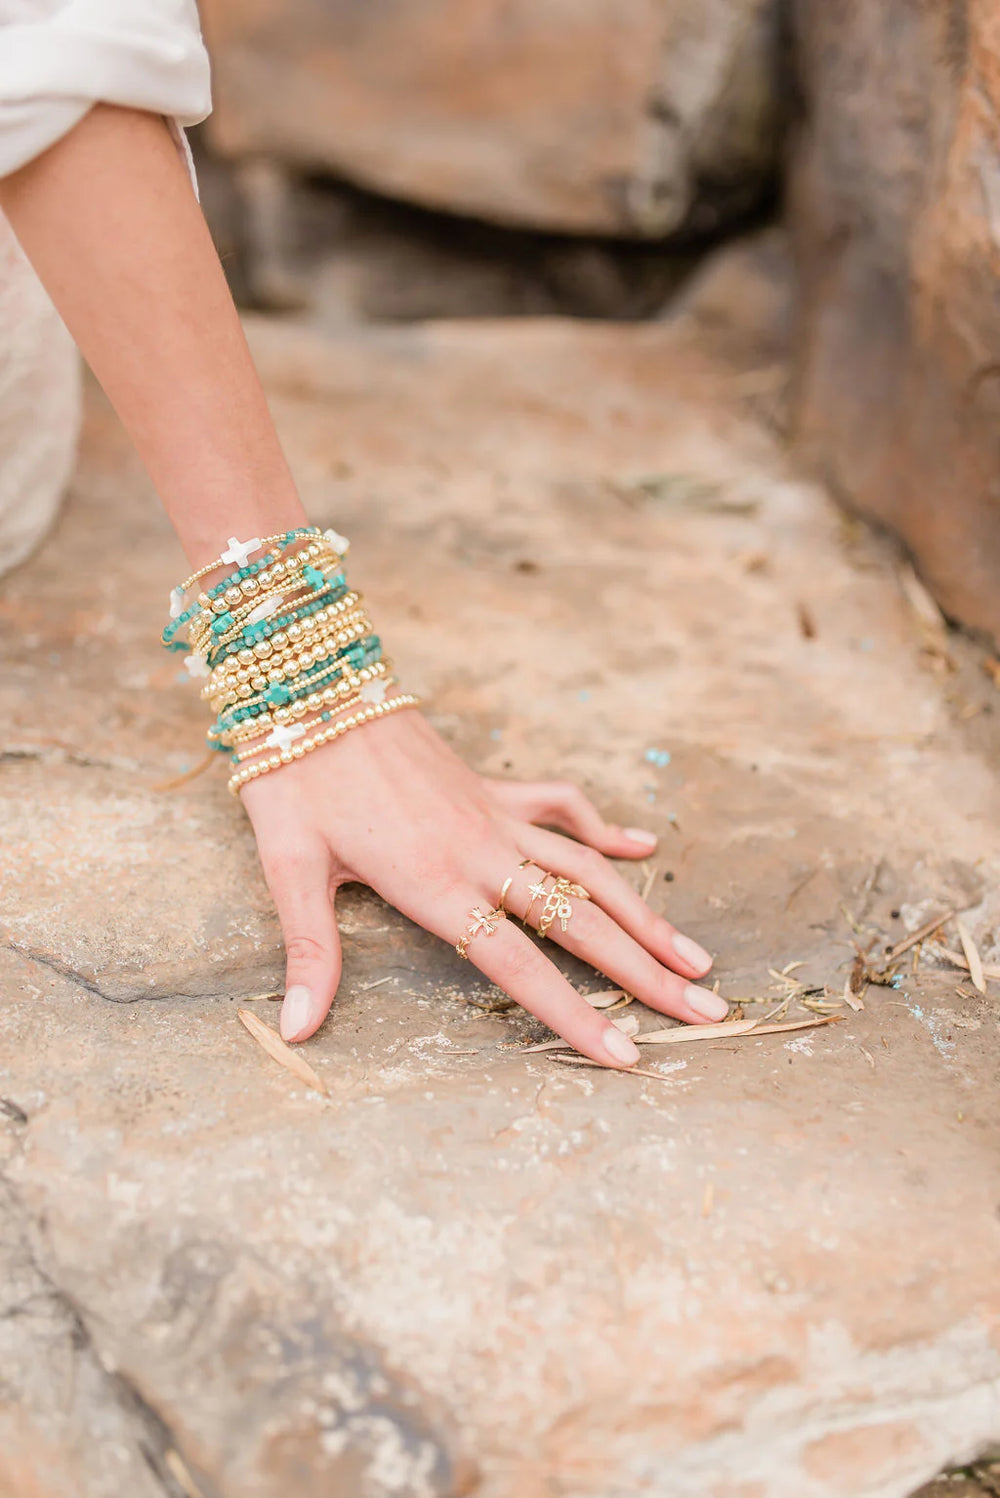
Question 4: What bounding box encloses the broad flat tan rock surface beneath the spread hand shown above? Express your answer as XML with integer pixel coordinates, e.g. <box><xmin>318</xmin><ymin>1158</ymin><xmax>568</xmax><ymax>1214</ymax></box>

<box><xmin>0</xmin><ymin>271</ymin><xmax>1000</xmax><ymax>1498</ymax></box>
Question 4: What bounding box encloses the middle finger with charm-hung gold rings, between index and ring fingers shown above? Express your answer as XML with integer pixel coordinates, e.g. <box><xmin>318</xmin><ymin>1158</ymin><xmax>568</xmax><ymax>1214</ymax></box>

<box><xmin>504</xmin><ymin>864</ymin><xmax>729</xmax><ymax>1025</ymax></box>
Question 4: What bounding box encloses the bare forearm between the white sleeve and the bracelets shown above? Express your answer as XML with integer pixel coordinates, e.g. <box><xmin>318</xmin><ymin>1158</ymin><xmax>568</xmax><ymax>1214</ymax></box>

<box><xmin>0</xmin><ymin>105</ymin><xmax>304</xmax><ymax>566</ymax></box>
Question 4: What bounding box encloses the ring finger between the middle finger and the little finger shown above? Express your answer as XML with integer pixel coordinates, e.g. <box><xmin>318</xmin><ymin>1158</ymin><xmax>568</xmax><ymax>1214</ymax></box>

<box><xmin>518</xmin><ymin>827</ymin><xmax>711</xmax><ymax>978</ymax></box>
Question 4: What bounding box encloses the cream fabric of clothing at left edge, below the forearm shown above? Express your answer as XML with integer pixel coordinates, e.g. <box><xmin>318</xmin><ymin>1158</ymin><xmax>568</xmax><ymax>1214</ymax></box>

<box><xmin>0</xmin><ymin>214</ymin><xmax>79</xmax><ymax>572</ymax></box>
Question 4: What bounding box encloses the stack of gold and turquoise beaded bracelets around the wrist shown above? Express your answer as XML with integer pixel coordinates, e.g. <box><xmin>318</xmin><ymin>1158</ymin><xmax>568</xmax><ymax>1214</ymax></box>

<box><xmin>162</xmin><ymin>526</ymin><xmax>418</xmax><ymax>794</ymax></box>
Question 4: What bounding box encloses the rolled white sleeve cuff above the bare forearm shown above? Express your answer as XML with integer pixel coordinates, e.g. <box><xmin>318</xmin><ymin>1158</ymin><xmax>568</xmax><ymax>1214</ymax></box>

<box><xmin>0</xmin><ymin>0</ymin><xmax>211</xmax><ymax>187</ymax></box>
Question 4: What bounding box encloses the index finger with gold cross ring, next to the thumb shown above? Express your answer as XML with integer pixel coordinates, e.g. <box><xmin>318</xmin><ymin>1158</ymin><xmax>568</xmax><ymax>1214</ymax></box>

<box><xmin>416</xmin><ymin>887</ymin><xmax>639</xmax><ymax>1068</ymax></box>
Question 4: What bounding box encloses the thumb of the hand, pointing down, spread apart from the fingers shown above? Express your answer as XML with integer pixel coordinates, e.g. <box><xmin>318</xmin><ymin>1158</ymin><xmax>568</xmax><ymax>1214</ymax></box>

<box><xmin>262</xmin><ymin>843</ymin><xmax>341</xmax><ymax>1041</ymax></box>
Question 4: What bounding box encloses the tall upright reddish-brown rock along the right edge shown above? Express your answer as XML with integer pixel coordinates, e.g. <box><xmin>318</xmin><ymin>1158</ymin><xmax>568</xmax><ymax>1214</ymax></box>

<box><xmin>790</xmin><ymin>0</ymin><xmax>1000</xmax><ymax>637</ymax></box>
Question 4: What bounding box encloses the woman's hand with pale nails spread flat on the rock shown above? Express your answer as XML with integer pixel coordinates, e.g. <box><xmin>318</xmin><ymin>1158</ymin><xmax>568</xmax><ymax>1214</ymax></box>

<box><xmin>241</xmin><ymin>709</ymin><xmax>726</xmax><ymax>1067</ymax></box>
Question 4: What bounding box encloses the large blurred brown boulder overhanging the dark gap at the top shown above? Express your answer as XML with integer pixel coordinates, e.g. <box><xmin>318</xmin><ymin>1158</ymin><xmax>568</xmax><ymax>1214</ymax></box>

<box><xmin>202</xmin><ymin>0</ymin><xmax>781</xmax><ymax>235</ymax></box>
